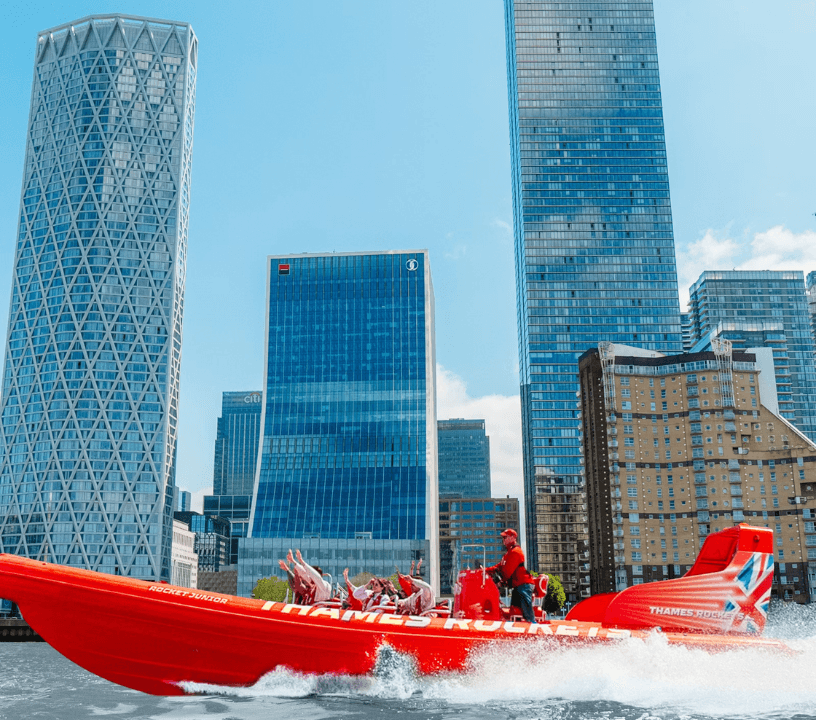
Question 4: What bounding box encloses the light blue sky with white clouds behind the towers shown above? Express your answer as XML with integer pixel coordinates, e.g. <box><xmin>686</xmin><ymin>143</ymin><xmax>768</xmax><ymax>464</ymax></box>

<box><xmin>0</xmin><ymin>0</ymin><xmax>816</xmax><ymax>509</ymax></box>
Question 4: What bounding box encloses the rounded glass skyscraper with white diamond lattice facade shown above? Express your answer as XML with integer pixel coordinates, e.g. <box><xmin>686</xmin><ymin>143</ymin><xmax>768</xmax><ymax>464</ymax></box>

<box><xmin>0</xmin><ymin>15</ymin><xmax>198</xmax><ymax>580</ymax></box>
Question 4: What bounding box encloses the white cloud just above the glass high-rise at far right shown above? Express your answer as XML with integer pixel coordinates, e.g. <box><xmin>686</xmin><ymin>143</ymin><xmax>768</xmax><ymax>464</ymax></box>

<box><xmin>677</xmin><ymin>225</ymin><xmax>816</xmax><ymax>308</ymax></box>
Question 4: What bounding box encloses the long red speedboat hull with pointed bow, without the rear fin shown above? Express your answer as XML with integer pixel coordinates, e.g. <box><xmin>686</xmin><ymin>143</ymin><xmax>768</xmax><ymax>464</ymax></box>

<box><xmin>0</xmin><ymin>555</ymin><xmax>785</xmax><ymax>695</ymax></box>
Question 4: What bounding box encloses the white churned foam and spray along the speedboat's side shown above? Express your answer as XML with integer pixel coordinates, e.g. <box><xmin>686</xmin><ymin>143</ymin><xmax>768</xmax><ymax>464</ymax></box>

<box><xmin>184</xmin><ymin>612</ymin><xmax>816</xmax><ymax>718</ymax></box>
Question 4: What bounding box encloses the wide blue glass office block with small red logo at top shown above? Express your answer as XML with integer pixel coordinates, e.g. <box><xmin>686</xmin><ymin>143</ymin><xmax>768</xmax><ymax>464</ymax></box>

<box><xmin>238</xmin><ymin>250</ymin><xmax>439</xmax><ymax>595</ymax></box>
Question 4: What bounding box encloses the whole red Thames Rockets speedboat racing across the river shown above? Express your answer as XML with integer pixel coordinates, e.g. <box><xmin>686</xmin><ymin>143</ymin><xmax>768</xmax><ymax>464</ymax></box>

<box><xmin>0</xmin><ymin>525</ymin><xmax>785</xmax><ymax>695</ymax></box>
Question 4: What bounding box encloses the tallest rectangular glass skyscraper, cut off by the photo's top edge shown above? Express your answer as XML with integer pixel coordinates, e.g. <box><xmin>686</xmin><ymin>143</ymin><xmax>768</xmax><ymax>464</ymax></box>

<box><xmin>505</xmin><ymin>0</ymin><xmax>682</xmax><ymax>580</ymax></box>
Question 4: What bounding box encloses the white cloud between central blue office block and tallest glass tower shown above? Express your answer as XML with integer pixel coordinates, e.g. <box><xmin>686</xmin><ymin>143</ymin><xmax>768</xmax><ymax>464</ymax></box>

<box><xmin>436</xmin><ymin>364</ymin><xmax>524</xmax><ymax>504</ymax></box>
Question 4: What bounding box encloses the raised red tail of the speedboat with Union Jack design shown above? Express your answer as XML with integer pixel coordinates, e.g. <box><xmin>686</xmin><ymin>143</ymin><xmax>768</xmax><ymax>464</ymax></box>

<box><xmin>567</xmin><ymin>525</ymin><xmax>774</xmax><ymax>635</ymax></box>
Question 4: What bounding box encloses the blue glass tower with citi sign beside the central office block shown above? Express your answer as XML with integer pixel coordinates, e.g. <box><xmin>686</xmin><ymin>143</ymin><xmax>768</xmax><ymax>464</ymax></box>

<box><xmin>204</xmin><ymin>392</ymin><xmax>263</xmax><ymax>565</ymax></box>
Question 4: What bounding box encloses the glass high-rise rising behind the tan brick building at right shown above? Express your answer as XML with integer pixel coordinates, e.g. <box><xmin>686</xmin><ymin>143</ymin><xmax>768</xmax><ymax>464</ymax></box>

<box><xmin>689</xmin><ymin>270</ymin><xmax>816</xmax><ymax>441</ymax></box>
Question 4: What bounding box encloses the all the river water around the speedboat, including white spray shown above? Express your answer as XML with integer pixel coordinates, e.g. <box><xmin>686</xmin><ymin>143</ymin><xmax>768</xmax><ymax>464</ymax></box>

<box><xmin>0</xmin><ymin>605</ymin><xmax>816</xmax><ymax>720</ymax></box>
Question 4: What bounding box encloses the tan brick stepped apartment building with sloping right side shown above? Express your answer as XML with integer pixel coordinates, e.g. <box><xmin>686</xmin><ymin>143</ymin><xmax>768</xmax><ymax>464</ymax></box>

<box><xmin>580</xmin><ymin>340</ymin><xmax>816</xmax><ymax>602</ymax></box>
